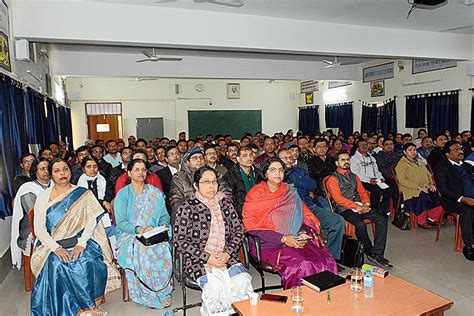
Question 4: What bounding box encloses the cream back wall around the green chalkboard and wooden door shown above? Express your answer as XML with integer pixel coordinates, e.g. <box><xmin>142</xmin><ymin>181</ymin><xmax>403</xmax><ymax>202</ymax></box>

<box><xmin>66</xmin><ymin>78</ymin><xmax>300</xmax><ymax>148</ymax></box>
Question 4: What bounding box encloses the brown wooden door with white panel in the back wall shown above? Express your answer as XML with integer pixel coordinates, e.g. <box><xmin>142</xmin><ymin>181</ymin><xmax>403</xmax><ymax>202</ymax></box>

<box><xmin>87</xmin><ymin>114</ymin><xmax>122</xmax><ymax>141</ymax></box>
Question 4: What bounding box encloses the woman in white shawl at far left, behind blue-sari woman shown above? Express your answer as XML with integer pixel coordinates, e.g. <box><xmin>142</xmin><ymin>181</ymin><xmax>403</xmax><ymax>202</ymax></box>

<box><xmin>10</xmin><ymin>157</ymin><xmax>51</xmax><ymax>270</ymax></box>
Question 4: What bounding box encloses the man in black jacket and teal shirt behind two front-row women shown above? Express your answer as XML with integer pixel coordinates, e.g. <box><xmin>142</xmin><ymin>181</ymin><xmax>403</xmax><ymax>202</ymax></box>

<box><xmin>224</xmin><ymin>147</ymin><xmax>255</xmax><ymax>219</ymax></box>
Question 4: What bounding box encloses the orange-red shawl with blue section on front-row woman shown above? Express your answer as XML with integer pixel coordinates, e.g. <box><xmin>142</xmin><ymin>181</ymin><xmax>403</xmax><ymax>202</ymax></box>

<box><xmin>242</xmin><ymin>181</ymin><xmax>320</xmax><ymax>235</ymax></box>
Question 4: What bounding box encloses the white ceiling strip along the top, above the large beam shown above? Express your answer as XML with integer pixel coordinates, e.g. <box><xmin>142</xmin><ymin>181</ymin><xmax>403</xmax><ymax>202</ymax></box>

<box><xmin>55</xmin><ymin>0</ymin><xmax>474</xmax><ymax>34</ymax></box>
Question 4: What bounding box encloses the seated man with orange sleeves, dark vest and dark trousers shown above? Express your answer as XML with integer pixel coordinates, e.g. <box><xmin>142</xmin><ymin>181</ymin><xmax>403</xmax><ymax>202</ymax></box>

<box><xmin>327</xmin><ymin>152</ymin><xmax>393</xmax><ymax>269</ymax></box>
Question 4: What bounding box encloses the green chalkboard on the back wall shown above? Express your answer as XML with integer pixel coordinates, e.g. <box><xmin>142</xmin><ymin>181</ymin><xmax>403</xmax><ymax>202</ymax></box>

<box><xmin>188</xmin><ymin>110</ymin><xmax>262</xmax><ymax>139</ymax></box>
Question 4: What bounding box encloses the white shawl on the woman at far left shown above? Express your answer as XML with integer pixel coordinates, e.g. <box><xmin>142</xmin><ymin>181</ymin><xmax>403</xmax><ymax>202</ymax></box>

<box><xmin>10</xmin><ymin>181</ymin><xmax>49</xmax><ymax>270</ymax></box>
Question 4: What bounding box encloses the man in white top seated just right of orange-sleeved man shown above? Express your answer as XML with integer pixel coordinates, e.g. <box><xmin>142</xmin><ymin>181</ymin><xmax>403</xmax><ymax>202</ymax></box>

<box><xmin>351</xmin><ymin>139</ymin><xmax>392</xmax><ymax>215</ymax></box>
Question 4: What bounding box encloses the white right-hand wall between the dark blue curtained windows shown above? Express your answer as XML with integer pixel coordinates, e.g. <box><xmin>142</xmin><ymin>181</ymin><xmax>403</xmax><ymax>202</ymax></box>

<box><xmin>312</xmin><ymin>60</ymin><xmax>474</xmax><ymax>133</ymax></box>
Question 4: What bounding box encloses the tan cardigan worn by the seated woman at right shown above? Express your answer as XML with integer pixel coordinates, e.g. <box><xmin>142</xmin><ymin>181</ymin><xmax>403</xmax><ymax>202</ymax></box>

<box><xmin>395</xmin><ymin>156</ymin><xmax>433</xmax><ymax>200</ymax></box>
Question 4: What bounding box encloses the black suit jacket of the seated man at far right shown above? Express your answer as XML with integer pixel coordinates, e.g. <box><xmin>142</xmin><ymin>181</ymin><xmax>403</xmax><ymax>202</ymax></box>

<box><xmin>434</xmin><ymin>159</ymin><xmax>474</xmax><ymax>212</ymax></box>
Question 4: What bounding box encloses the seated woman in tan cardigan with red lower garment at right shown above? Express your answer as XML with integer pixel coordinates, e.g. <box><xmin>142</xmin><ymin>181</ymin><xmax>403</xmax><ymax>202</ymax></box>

<box><xmin>395</xmin><ymin>143</ymin><xmax>443</xmax><ymax>228</ymax></box>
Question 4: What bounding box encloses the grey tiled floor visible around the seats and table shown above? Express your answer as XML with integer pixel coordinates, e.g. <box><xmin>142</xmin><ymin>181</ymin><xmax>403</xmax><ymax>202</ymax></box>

<box><xmin>0</xmin><ymin>224</ymin><xmax>474</xmax><ymax>316</ymax></box>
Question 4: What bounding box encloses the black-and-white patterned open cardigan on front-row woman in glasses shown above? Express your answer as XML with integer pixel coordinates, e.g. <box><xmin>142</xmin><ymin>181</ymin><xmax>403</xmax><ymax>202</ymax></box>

<box><xmin>173</xmin><ymin>194</ymin><xmax>244</xmax><ymax>280</ymax></box>
